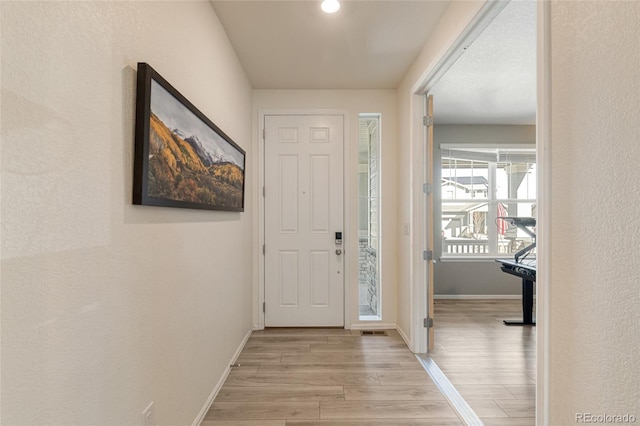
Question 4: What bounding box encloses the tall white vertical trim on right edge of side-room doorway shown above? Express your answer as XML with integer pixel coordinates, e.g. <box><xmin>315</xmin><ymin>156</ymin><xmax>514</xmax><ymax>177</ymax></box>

<box><xmin>536</xmin><ymin>1</ymin><xmax>552</xmax><ymax>425</ymax></box>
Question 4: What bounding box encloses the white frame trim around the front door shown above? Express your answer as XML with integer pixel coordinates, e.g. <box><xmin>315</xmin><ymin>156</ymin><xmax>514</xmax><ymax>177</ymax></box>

<box><xmin>254</xmin><ymin>109</ymin><xmax>350</xmax><ymax>330</ymax></box>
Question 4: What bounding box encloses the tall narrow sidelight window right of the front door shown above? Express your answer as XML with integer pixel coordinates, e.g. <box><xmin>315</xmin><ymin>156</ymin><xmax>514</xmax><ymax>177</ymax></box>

<box><xmin>358</xmin><ymin>114</ymin><xmax>382</xmax><ymax>321</ymax></box>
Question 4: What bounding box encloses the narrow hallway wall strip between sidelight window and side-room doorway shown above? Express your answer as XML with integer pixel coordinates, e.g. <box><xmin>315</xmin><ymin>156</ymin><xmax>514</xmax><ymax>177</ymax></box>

<box><xmin>396</xmin><ymin>1</ymin><xmax>484</xmax><ymax>342</ymax></box>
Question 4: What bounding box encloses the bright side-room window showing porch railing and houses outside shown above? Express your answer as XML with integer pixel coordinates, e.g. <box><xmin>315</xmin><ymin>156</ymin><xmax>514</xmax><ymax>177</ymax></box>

<box><xmin>441</xmin><ymin>145</ymin><xmax>537</xmax><ymax>258</ymax></box>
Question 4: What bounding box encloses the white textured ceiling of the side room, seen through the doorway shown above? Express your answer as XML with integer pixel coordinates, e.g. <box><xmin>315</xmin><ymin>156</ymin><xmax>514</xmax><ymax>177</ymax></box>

<box><xmin>429</xmin><ymin>0</ymin><xmax>536</xmax><ymax>124</ymax></box>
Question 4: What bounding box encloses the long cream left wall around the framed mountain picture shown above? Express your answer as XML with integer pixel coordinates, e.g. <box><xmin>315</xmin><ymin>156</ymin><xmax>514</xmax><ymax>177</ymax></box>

<box><xmin>1</xmin><ymin>1</ymin><xmax>253</xmax><ymax>425</ymax></box>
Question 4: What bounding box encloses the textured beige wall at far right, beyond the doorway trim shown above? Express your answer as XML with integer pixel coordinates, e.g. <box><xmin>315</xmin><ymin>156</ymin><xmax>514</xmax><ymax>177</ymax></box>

<box><xmin>548</xmin><ymin>1</ymin><xmax>640</xmax><ymax>425</ymax></box>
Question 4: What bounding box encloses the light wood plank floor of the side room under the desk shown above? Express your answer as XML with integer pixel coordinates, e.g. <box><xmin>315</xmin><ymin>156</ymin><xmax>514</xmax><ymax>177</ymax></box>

<box><xmin>429</xmin><ymin>300</ymin><xmax>536</xmax><ymax>426</ymax></box>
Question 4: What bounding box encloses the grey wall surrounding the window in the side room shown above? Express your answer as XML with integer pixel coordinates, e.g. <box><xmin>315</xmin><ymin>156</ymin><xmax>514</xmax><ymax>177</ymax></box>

<box><xmin>433</xmin><ymin>125</ymin><xmax>536</xmax><ymax>296</ymax></box>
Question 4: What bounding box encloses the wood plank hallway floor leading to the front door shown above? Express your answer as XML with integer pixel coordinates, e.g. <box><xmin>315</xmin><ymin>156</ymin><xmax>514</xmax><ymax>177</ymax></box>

<box><xmin>202</xmin><ymin>329</ymin><xmax>462</xmax><ymax>426</ymax></box>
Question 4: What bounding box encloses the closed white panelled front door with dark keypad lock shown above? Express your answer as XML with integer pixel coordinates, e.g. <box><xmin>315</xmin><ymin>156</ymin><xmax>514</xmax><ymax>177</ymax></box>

<box><xmin>264</xmin><ymin>115</ymin><xmax>344</xmax><ymax>327</ymax></box>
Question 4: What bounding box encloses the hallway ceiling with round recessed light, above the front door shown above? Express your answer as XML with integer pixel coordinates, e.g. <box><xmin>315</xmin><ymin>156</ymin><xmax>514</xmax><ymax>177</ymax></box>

<box><xmin>211</xmin><ymin>0</ymin><xmax>449</xmax><ymax>89</ymax></box>
